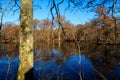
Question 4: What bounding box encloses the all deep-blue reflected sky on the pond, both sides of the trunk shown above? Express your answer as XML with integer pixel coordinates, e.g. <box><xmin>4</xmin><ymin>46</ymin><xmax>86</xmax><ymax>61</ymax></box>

<box><xmin>0</xmin><ymin>54</ymin><xmax>120</xmax><ymax>80</ymax></box>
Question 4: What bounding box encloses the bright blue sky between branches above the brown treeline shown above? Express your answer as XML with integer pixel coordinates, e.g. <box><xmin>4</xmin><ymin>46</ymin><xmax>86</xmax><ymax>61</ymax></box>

<box><xmin>0</xmin><ymin>0</ymin><xmax>95</xmax><ymax>25</ymax></box>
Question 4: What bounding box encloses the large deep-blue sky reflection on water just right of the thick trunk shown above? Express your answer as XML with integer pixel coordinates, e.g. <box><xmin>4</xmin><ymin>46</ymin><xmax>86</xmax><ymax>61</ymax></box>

<box><xmin>34</xmin><ymin>54</ymin><xmax>96</xmax><ymax>80</ymax></box>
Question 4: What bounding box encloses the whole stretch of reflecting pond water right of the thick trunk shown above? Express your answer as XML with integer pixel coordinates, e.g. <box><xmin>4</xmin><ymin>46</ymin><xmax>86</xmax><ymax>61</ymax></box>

<box><xmin>34</xmin><ymin>43</ymin><xmax>120</xmax><ymax>80</ymax></box>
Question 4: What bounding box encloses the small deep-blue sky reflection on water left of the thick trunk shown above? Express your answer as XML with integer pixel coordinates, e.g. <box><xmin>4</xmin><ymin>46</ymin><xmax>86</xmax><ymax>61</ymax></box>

<box><xmin>0</xmin><ymin>57</ymin><xmax>19</xmax><ymax>80</ymax></box>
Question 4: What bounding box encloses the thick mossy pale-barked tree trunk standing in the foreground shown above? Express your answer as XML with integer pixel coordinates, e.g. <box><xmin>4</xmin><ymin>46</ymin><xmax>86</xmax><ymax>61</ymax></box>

<box><xmin>17</xmin><ymin>0</ymin><xmax>33</xmax><ymax>80</ymax></box>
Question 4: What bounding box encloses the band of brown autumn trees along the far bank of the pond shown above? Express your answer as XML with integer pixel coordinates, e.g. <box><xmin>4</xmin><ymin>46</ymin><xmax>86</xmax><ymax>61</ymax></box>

<box><xmin>2</xmin><ymin>13</ymin><xmax>120</xmax><ymax>44</ymax></box>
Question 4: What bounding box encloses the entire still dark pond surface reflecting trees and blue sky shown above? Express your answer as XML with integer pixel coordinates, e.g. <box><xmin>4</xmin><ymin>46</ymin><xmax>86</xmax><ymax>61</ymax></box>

<box><xmin>0</xmin><ymin>43</ymin><xmax>120</xmax><ymax>80</ymax></box>
